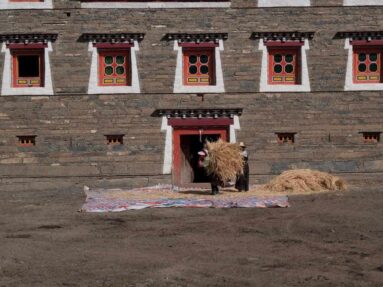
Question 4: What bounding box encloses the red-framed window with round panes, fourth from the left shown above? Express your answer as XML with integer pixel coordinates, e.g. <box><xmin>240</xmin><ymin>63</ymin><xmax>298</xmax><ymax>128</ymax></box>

<box><xmin>269</xmin><ymin>47</ymin><xmax>300</xmax><ymax>85</ymax></box>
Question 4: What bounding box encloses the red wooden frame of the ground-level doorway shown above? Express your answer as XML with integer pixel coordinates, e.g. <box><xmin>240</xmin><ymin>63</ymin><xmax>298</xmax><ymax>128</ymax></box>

<box><xmin>173</xmin><ymin>126</ymin><xmax>229</xmax><ymax>185</ymax></box>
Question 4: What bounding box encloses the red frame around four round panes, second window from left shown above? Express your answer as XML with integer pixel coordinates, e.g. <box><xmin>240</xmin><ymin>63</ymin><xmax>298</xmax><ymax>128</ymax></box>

<box><xmin>98</xmin><ymin>48</ymin><xmax>131</xmax><ymax>86</ymax></box>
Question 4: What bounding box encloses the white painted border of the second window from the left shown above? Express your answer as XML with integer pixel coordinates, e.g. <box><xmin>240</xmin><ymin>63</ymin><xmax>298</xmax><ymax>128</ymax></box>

<box><xmin>88</xmin><ymin>41</ymin><xmax>140</xmax><ymax>94</ymax></box>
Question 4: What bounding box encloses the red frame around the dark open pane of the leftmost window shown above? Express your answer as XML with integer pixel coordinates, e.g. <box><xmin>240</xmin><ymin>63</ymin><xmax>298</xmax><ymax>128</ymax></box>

<box><xmin>11</xmin><ymin>48</ymin><xmax>45</xmax><ymax>88</ymax></box>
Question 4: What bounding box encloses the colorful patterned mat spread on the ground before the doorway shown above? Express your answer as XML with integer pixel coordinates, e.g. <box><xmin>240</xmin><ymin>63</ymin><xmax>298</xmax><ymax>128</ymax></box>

<box><xmin>81</xmin><ymin>185</ymin><xmax>289</xmax><ymax>212</ymax></box>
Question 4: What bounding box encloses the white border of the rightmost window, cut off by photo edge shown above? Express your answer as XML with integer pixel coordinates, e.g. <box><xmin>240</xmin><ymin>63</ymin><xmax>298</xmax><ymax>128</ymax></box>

<box><xmin>344</xmin><ymin>38</ymin><xmax>383</xmax><ymax>91</ymax></box>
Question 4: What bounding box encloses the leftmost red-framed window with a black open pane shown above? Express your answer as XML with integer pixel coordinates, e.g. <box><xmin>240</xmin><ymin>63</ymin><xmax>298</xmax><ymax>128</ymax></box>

<box><xmin>11</xmin><ymin>49</ymin><xmax>44</xmax><ymax>87</ymax></box>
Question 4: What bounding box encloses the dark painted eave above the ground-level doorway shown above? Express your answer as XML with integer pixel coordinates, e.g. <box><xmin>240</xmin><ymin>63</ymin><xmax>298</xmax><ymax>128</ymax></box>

<box><xmin>152</xmin><ymin>108</ymin><xmax>243</xmax><ymax>119</ymax></box>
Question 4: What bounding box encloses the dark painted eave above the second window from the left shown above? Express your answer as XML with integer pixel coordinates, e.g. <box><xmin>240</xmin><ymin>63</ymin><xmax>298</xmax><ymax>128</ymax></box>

<box><xmin>80</xmin><ymin>33</ymin><xmax>145</xmax><ymax>43</ymax></box>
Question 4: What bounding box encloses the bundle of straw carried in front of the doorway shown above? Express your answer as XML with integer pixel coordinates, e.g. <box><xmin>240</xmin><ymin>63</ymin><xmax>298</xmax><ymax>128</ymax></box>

<box><xmin>206</xmin><ymin>139</ymin><xmax>243</xmax><ymax>183</ymax></box>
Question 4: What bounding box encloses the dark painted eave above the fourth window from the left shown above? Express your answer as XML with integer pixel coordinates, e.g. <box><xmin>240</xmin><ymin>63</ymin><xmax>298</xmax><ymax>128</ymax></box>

<box><xmin>250</xmin><ymin>31</ymin><xmax>315</xmax><ymax>42</ymax></box>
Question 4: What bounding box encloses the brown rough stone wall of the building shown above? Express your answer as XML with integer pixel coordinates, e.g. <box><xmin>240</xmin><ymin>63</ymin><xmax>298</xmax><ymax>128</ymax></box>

<box><xmin>0</xmin><ymin>0</ymin><xmax>383</xmax><ymax>191</ymax></box>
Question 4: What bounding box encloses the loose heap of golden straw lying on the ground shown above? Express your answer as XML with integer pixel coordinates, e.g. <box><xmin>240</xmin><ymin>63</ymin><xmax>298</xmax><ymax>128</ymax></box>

<box><xmin>264</xmin><ymin>169</ymin><xmax>346</xmax><ymax>193</ymax></box>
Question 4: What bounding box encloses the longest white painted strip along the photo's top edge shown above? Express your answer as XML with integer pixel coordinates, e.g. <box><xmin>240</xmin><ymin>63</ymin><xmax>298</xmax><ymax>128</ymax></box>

<box><xmin>81</xmin><ymin>1</ymin><xmax>231</xmax><ymax>9</ymax></box>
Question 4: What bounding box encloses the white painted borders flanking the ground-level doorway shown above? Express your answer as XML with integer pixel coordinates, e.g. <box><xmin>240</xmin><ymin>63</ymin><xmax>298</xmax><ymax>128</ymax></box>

<box><xmin>161</xmin><ymin>115</ymin><xmax>241</xmax><ymax>174</ymax></box>
